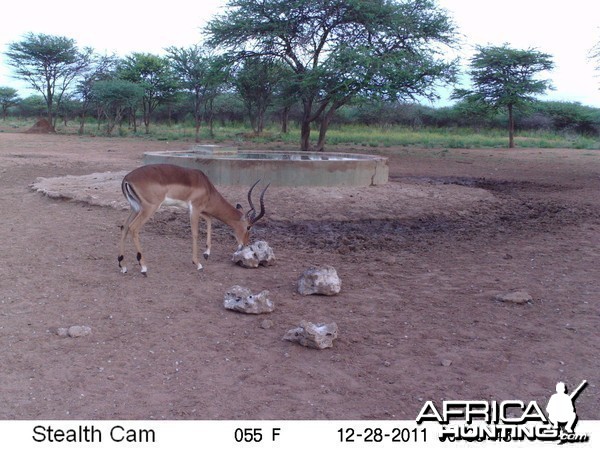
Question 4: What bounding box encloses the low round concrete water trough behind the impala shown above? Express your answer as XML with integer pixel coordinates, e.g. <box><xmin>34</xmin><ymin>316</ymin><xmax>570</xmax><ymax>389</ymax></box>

<box><xmin>144</xmin><ymin>145</ymin><xmax>389</xmax><ymax>186</ymax></box>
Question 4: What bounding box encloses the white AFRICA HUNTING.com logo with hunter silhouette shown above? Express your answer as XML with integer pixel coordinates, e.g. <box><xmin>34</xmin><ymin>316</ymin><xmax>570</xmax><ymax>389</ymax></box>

<box><xmin>417</xmin><ymin>380</ymin><xmax>589</xmax><ymax>443</ymax></box>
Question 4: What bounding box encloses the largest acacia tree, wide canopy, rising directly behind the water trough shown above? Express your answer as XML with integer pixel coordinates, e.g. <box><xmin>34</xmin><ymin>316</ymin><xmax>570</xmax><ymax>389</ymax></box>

<box><xmin>206</xmin><ymin>0</ymin><xmax>456</xmax><ymax>150</ymax></box>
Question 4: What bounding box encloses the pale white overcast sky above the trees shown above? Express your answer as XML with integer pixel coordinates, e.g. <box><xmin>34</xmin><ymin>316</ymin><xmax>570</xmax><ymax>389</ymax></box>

<box><xmin>0</xmin><ymin>0</ymin><xmax>600</xmax><ymax>107</ymax></box>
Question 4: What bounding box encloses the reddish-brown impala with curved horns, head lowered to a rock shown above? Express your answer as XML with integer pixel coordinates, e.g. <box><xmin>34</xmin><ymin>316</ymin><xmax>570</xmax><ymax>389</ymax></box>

<box><xmin>118</xmin><ymin>164</ymin><xmax>269</xmax><ymax>275</ymax></box>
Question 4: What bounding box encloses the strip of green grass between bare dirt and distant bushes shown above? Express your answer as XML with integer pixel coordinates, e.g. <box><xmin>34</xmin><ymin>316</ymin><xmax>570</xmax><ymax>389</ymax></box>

<box><xmin>0</xmin><ymin>120</ymin><xmax>600</xmax><ymax>150</ymax></box>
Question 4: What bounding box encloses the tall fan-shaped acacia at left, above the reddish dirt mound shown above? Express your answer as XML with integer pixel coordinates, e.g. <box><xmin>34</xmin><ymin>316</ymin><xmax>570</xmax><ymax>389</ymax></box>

<box><xmin>5</xmin><ymin>33</ymin><xmax>93</xmax><ymax>127</ymax></box>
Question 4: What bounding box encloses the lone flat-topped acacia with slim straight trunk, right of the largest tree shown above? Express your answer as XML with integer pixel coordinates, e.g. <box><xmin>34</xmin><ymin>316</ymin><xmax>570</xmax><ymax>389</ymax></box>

<box><xmin>452</xmin><ymin>44</ymin><xmax>554</xmax><ymax>148</ymax></box>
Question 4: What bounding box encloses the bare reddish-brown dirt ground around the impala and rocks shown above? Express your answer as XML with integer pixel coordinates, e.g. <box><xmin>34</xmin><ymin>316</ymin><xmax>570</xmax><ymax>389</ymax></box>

<box><xmin>0</xmin><ymin>132</ymin><xmax>600</xmax><ymax>420</ymax></box>
